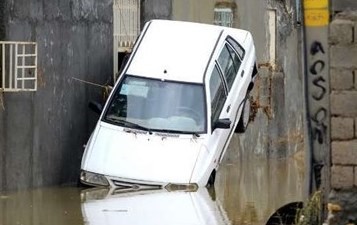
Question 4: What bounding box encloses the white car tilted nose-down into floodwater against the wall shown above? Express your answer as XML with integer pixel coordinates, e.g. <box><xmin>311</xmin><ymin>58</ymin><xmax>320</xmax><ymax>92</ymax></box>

<box><xmin>80</xmin><ymin>20</ymin><xmax>257</xmax><ymax>188</ymax></box>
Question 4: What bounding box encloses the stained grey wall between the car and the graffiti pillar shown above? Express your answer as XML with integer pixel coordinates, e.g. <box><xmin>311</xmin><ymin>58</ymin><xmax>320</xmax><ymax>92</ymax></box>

<box><xmin>231</xmin><ymin>0</ymin><xmax>304</xmax><ymax>158</ymax></box>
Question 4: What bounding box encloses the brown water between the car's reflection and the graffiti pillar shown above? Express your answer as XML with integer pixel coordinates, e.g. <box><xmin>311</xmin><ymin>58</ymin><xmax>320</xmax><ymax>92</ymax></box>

<box><xmin>216</xmin><ymin>157</ymin><xmax>304</xmax><ymax>225</ymax></box>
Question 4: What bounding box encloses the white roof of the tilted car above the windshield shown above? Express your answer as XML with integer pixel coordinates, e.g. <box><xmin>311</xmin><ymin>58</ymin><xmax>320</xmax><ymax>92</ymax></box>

<box><xmin>126</xmin><ymin>20</ymin><xmax>248</xmax><ymax>83</ymax></box>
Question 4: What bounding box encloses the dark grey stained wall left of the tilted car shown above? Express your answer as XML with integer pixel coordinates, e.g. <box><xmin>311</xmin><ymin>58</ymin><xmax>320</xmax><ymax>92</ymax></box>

<box><xmin>0</xmin><ymin>0</ymin><xmax>113</xmax><ymax>190</ymax></box>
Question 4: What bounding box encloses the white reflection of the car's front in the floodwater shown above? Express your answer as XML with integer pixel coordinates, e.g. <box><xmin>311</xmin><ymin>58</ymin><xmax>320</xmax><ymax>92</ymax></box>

<box><xmin>82</xmin><ymin>188</ymin><xmax>230</xmax><ymax>225</ymax></box>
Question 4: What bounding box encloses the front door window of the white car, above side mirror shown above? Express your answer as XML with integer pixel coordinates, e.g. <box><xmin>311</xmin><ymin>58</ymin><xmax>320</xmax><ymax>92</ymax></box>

<box><xmin>209</xmin><ymin>66</ymin><xmax>227</xmax><ymax>124</ymax></box>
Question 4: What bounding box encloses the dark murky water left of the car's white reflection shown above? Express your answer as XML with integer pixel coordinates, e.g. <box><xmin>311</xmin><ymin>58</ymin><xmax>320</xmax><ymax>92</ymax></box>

<box><xmin>0</xmin><ymin>187</ymin><xmax>84</xmax><ymax>225</ymax></box>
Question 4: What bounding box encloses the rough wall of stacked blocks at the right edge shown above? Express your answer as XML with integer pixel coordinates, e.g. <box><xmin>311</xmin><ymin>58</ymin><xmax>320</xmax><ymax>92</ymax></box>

<box><xmin>329</xmin><ymin>11</ymin><xmax>357</xmax><ymax>224</ymax></box>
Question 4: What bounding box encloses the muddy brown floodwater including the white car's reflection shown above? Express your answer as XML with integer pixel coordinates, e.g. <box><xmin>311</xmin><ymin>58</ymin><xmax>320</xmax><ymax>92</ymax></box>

<box><xmin>0</xmin><ymin>155</ymin><xmax>304</xmax><ymax>225</ymax></box>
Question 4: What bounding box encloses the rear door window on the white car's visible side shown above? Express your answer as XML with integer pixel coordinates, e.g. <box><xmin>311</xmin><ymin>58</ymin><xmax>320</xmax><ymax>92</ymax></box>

<box><xmin>217</xmin><ymin>44</ymin><xmax>241</xmax><ymax>90</ymax></box>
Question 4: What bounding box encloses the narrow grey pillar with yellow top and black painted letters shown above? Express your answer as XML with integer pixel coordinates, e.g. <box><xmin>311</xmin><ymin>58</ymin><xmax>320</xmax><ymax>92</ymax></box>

<box><xmin>304</xmin><ymin>0</ymin><xmax>330</xmax><ymax>192</ymax></box>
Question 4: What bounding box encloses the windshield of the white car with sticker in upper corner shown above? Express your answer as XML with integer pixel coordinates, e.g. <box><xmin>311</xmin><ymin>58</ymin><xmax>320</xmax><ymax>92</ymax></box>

<box><xmin>103</xmin><ymin>75</ymin><xmax>206</xmax><ymax>134</ymax></box>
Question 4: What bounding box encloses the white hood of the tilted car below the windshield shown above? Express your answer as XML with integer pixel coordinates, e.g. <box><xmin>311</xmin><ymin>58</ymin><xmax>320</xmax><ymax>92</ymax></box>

<box><xmin>82</xmin><ymin>122</ymin><xmax>201</xmax><ymax>183</ymax></box>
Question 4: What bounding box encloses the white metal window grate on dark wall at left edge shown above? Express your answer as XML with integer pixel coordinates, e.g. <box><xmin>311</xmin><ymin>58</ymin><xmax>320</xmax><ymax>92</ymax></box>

<box><xmin>0</xmin><ymin>41</ymin><xmax>37</xmax><ymax>92</ymax></box>
